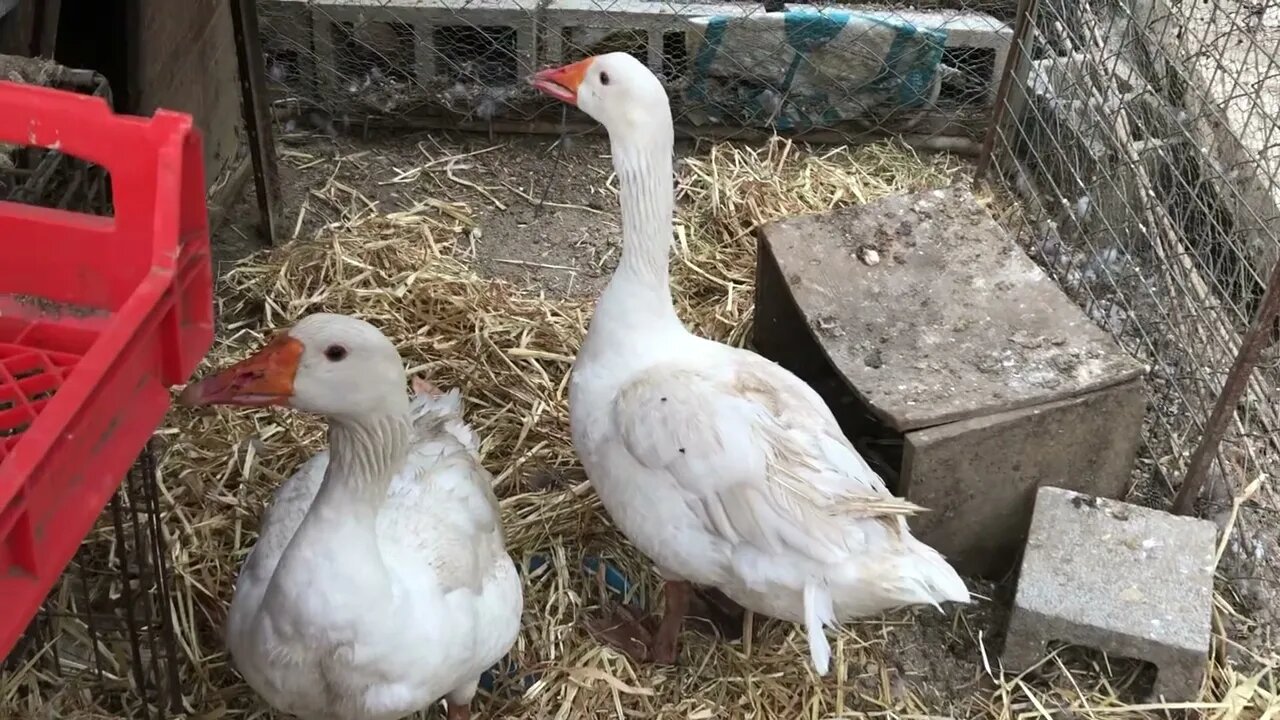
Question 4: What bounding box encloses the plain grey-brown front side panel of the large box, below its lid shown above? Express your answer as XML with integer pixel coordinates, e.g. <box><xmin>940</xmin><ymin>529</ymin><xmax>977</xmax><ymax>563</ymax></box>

<box><xmin>900</xmin><ymin>379</ymin><xmax>1147</xmax><ymax>577</ymax></box>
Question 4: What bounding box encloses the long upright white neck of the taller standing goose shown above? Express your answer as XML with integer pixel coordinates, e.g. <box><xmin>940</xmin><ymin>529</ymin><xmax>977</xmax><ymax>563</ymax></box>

<box><xmin>600</xmin><ymin>132</ymin><xmax>678</xmax><ymax>324</ymax></box>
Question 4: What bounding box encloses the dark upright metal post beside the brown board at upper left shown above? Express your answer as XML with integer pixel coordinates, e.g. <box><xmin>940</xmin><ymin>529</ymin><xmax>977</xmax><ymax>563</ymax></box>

<box><xmin>232</xmin><ymin>0</ymin><xmax>280</xmax><ymax>246</ymax></box>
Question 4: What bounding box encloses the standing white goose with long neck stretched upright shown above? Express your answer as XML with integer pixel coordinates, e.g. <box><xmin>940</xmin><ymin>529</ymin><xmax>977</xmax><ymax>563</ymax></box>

<box><xmin>531</xmin><ymin>53</ymin><xmax>969</xmax><ymax>674</ymax></box>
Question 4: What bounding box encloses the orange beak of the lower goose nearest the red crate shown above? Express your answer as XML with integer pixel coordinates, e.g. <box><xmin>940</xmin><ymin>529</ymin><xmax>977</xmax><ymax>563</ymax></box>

<box><xmin>178</xmin><ymin>333</ymin><xmax>302</xmax><ymax>407</ymax></box>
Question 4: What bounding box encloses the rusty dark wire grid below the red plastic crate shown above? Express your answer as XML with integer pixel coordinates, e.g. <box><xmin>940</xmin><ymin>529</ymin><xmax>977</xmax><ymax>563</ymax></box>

<box><xmin>5</xmin><ymin>446</ymin><xmax>183</xmax><ymax>720</ymax></box>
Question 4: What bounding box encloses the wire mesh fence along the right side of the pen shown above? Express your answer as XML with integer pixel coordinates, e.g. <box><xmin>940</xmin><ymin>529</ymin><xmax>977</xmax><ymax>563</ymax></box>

<box><xmin>993</xmin><ymin>0</ymin><xmax>1280</xmax><ymax>609</ymax></box>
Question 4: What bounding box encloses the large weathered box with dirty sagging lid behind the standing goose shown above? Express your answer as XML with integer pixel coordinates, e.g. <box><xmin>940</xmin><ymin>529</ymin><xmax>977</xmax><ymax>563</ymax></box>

<box><xmin>753</xmin><ymin>188</ymin><xmax>1144</xmax><ymax>578</ymax></box>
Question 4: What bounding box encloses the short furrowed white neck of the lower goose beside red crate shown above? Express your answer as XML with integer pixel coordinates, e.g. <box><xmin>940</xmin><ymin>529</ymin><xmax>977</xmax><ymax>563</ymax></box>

<box><xmin>276</xmin><ymin>414</ymin><xmax>411</xmax><ymax>602</ymax></box>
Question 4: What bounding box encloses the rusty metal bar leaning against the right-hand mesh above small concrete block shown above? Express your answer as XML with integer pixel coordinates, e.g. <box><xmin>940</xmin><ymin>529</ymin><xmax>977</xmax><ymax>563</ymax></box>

<box><xmin>1174</xmin><ymin>254</ymin><xmax>1280</xmax><ymax>515</ymax></box>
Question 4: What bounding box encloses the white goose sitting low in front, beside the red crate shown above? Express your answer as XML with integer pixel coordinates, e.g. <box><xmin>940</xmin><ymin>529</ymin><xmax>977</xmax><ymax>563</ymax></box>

<box><xmin>180</xmin><ymin>314</ymin><xmax>524</xmax><ymax>720</ymax></box>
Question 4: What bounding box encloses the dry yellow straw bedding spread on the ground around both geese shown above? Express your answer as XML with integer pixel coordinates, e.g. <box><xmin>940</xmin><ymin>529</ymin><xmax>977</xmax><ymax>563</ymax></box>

<box><xmin>0</xmin><ymin>135</ymin><xmax>1280</xmax><ymax>720</ymax></box>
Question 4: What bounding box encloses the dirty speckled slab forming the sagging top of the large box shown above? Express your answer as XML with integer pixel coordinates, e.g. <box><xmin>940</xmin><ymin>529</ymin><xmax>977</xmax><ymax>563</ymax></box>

<box><xmin>758</xmin><ymin>187</ymin><xmax>1143</xmax><ymax>432</ymax></box>
